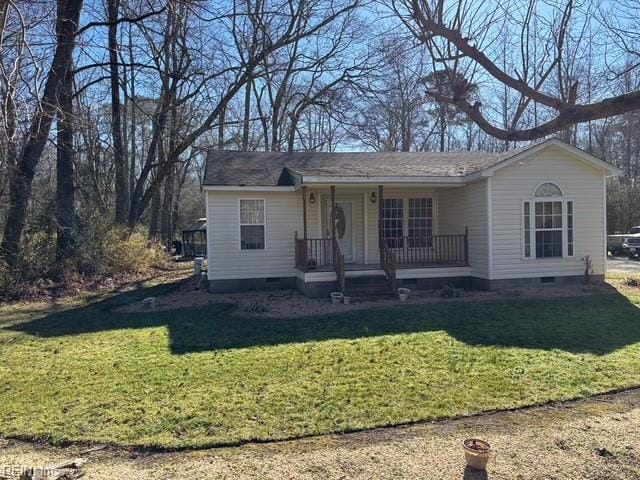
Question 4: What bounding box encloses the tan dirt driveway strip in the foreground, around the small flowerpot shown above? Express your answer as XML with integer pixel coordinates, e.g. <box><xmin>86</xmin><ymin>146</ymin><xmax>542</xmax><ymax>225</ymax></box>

<box><xmin>0</xmin><ymin>390</ymin><xmax>640</xmax><ymax>480</ymax></box>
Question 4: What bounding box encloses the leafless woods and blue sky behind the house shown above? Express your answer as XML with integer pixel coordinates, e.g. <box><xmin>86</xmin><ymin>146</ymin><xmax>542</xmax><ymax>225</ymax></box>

<box><xmin>0</xmin><ymin>0</ymin><xmax>640</xmax><ymax>286</ymax></box>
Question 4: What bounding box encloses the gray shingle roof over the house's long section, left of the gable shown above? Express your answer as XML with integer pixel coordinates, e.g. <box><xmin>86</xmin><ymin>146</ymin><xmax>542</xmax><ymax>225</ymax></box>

<box><xmin>204</xmin><ymin>149</ymin><xmax>524</xmax><ymax>186</ymax></box>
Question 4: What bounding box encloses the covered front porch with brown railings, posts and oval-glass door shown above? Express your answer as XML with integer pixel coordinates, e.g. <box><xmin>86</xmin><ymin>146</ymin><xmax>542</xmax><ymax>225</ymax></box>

<box><xmin>295</xmin><ymin>185</ymin><xmax>469</xmax><ymax>294</ymax></box>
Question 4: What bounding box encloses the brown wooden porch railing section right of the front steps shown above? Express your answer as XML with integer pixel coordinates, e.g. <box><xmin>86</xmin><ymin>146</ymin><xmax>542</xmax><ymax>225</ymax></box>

<box><xmin>383</xmin><ymin>229</ymin><xmax>469</xmax><ymax>266</ymax></box>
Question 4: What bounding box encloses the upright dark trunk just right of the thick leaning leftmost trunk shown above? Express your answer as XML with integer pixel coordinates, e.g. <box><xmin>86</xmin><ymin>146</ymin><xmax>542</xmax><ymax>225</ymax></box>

<box><xmin>56</xmin><ymin>68</ymin><xmax>76</xmax><ymax>260</ymax></box>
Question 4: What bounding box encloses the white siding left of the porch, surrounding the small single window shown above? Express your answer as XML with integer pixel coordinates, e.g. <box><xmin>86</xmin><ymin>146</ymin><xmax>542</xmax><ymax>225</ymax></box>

<box><xmin>206</xmin><ymin>191</ymin><xmax>302</xmax><ymax>280</ymax></box>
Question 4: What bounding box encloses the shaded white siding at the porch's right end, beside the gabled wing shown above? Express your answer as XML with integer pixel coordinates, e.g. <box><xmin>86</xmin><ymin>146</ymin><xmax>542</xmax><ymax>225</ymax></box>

<box><xmin>438</xmin><ymin>180</ymin><xmax>489</xmax><ymax>278</ymax></box>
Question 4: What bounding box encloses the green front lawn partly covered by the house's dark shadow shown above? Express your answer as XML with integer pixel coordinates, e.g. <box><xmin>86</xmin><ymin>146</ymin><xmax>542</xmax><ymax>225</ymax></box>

<box><xmin>0</xmin><ymin>286</ymin><xmax>640</xmax><ymax>448</ymax></box>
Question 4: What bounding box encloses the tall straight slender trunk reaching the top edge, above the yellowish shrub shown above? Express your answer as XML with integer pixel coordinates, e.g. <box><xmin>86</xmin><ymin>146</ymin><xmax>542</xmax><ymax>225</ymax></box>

<box><xmin>107</xmin><ymin>0</ymin><xmax>129</xmax><ymax>225</ymax></box>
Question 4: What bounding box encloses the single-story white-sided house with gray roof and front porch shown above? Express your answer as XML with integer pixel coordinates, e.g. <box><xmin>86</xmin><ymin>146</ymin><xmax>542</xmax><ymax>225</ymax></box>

<box><xmin>203</xmin><ymin>139</ymin><xmax>619</xmax><ymax>296</ymax></box>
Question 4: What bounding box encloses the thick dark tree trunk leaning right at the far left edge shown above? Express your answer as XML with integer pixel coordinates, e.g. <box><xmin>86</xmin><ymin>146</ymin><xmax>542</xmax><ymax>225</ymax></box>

<box><xmin>0</xmin><ymin>0</ymin><xmax>82</xmax><ymax>267</ymax></box>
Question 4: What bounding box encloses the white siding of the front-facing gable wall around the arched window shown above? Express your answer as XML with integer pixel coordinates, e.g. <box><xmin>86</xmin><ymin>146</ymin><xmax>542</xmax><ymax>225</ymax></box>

<box><xmin>490</xmin><ymin>147</ymin><xmax>605</xmax><ymax>279</ymax></box>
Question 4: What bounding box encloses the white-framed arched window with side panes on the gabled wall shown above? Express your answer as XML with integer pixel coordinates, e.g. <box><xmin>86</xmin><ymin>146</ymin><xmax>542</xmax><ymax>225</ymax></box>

<box><xmin>522</xmin><ymin>182</ymin><xmax>574</xmax><ymax>258</ymax></box>
